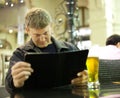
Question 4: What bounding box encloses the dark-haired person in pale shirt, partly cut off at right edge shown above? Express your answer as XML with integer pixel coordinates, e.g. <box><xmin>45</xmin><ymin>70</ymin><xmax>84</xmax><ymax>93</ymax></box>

<box><xmin>89</xmin><ymin>34</ymin><xmax>120</xmax><ymax>60</ymax></box>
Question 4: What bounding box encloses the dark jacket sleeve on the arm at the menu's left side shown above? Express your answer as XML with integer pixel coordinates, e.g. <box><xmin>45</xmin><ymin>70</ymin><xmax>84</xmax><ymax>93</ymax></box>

<box><xmin>5</xmin><ymin>48</ymin><xmax>25</xmax><ymax>93</ymax></box>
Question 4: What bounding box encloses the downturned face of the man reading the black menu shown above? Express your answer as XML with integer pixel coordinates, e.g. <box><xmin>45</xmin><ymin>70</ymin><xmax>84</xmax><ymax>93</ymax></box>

<box><xmin>26</xmin><ymin>25</ymin><xmax>52</xmax><ymax>48</ymax></box>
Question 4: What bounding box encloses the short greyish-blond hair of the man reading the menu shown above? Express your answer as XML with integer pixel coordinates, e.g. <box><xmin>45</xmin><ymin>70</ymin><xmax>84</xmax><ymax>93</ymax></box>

<box><xmin>25</xmin><ymin>8</ymin><xmax>52</xmax><ymax>29</ymax></box>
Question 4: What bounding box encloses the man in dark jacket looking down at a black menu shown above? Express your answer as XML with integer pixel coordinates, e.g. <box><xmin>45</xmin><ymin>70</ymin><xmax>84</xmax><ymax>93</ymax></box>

<box><xmin>5</xmin><ymin>8</ymin><xmax>87</xmax><ymax>92</ymax></box>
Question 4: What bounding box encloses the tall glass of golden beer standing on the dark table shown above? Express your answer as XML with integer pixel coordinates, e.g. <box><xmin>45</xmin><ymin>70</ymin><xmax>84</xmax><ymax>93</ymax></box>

<box><xmin>86</xmin><ymin>57</ymin><xmax>100</xmax><ymax>89</ymax></box>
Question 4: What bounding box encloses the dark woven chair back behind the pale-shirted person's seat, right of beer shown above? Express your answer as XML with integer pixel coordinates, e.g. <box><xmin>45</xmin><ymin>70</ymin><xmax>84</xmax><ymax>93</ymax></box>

<box><xmin>99</xmin><ymin>59</ymin><xmax>120</xmax><ymax>87</ymax></box>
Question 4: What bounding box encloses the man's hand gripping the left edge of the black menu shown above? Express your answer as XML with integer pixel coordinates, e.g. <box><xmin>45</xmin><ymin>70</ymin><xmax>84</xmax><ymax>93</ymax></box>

<box><xmin>11</xmin><ymin>62</ymin><xmax>33</xmax><ymax>88</ymax></box>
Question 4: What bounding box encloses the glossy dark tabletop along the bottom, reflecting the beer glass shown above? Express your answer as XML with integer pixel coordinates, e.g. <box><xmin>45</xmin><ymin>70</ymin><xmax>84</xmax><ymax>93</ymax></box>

<box><xmin>0</xmin><ymin>83</ymin><xmax>120</xmax><ymax>98</ymax></box>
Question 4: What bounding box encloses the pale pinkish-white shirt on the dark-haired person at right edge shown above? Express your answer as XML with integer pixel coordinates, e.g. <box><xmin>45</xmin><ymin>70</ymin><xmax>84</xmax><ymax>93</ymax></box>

<box><xmin>89</xmin><ymin>45</ymin><xmax>120</xmax><ymax>60</ymax></box>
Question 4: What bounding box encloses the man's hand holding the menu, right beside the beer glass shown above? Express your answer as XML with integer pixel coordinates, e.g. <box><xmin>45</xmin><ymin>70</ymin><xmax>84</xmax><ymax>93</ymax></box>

<box><xmin>71</xmin><ymin>70</ymin><xmax>88</xmax><ymax>87</ymax></box>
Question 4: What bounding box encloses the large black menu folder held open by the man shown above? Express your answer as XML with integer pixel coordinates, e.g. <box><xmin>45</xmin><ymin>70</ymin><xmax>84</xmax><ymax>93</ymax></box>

<box><xmin>24</xmin><ymin>49</ymin><xmax>88</xmax><ymax>89</ymax></box>
